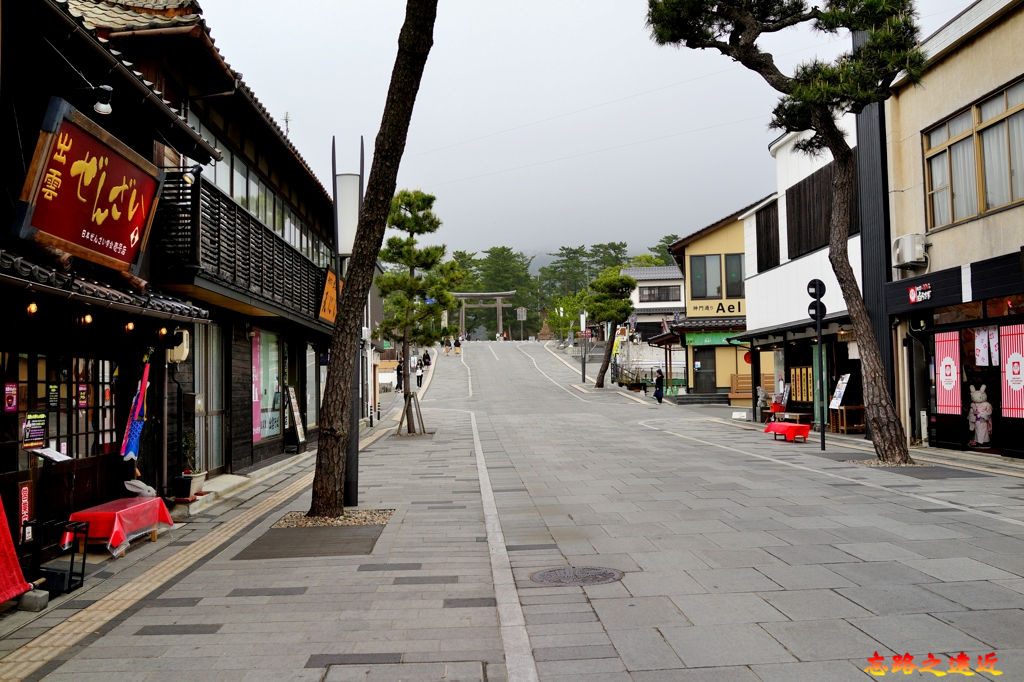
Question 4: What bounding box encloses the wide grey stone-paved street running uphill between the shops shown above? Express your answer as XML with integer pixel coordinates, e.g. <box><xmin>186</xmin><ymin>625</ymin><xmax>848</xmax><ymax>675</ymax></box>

<box><xmin>0</xmin><ymin>342</ymin><xmax>1024</xmax><ymax>682</ymax></box>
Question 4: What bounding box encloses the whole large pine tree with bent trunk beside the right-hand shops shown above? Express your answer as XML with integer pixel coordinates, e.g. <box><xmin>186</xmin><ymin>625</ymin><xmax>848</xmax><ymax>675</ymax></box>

<box><xmin>647</xmin><ymin>0</ymin><xmax>925</xmax><ymax>464</ymax></box>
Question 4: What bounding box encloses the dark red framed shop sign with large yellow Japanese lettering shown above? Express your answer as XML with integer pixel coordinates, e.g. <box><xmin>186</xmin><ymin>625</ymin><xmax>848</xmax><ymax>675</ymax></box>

<box><xmin>19</xmin><ymin>97</ymin><xmax>164</xmax><ymax>270</ymax></box>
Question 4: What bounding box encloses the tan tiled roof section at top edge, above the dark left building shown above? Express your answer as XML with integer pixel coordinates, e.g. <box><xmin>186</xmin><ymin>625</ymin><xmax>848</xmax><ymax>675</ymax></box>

<box><xmin>65</xmin><ymin>0</ymin><xmax>202</xmax><ymax>31</ymax></box>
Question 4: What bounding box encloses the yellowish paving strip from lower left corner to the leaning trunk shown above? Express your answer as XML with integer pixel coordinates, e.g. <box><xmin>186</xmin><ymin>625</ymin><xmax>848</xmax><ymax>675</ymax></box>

<box><xmin>0</xmin><ymin>473</ymin><xmax>313</xmax><ymax>680</ymax></box>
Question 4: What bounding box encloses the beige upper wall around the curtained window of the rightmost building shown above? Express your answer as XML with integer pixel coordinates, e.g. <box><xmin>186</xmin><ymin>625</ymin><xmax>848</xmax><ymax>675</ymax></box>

<box><xmin>886</xmin><ymin>5</ymin><xmax>1024</xmax><ymax>274</ymax></box>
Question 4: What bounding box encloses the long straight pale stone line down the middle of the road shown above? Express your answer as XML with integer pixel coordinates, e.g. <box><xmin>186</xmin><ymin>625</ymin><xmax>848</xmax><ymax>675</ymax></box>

<box><xmin>469</xmin><ymin>412</ymin><xmax>539</xmax><ymax>682</ymax></box>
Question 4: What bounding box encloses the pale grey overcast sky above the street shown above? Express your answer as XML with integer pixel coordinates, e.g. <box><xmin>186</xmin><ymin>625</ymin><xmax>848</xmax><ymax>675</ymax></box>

<box><xmin>201</xmin><ymin>0</ymin><xmax>970</xmax><ymax>260</ymax></box>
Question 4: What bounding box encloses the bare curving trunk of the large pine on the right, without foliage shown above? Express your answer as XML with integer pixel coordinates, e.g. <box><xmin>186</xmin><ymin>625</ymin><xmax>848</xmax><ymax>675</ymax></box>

<box><xmin>814</xmin><ymin>112</ymin><xmax>913</xmax><ymax>464</ymax></box>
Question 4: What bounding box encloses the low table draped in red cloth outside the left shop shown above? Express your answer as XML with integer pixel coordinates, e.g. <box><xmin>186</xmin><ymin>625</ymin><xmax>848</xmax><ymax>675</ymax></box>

<box><xmin>61</xmin><ymin>498</ymin><xmax>174</xmax><ymax>556</ymax></box>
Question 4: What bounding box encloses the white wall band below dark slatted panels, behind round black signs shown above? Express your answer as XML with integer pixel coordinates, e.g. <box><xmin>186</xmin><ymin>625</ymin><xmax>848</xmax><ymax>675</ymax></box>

<box><xmin>746</xmin><ymin>235</ymin><xmax>863</xmax><ymax>330</ymax></box>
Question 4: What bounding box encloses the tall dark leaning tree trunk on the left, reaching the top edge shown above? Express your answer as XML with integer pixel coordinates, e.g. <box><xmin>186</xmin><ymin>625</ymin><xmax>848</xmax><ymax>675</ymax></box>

<box><xmin>309</xmin><ymin>0</ymin><xmax>437</xmax><ymax>509</ymax></box>
